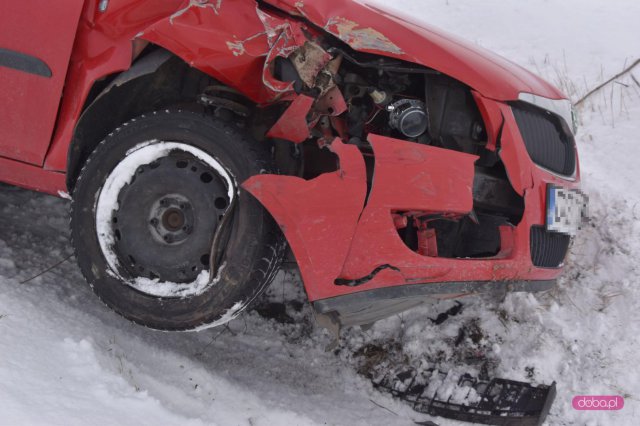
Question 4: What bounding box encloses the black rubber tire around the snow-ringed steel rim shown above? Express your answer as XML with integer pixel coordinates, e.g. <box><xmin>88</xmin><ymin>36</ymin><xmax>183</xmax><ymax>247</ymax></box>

<box><xmin>71</xmin><ymin>110</ymin><xmax>285</xmax><ymax>330</ymax></box>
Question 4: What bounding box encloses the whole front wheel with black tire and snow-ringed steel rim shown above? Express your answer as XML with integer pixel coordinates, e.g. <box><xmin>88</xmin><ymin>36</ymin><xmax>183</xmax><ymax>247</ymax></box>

<box><xmin>71</xmin><ymin>111</ymin><xmax>284</xmax><ymax>330</ymax></box>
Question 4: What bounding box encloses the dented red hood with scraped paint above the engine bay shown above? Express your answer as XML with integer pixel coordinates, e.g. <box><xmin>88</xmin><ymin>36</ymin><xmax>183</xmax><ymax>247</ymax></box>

<box><xmin>266</xmin><ymin>0</ymin><xmax>566</xmax><ymax>101</ymax></box>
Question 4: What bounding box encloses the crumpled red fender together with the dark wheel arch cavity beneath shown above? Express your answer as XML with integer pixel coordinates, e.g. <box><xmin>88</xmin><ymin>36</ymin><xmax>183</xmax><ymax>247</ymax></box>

<box><xmin>64</xmin><ymin>0</ymin><xmax>306</xmax><ymax>192</ymax></box>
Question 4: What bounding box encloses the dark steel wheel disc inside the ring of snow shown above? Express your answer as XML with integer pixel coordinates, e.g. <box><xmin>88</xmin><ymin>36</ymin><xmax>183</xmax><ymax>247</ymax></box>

<box><xmin>111</xmin><ymin>151</ymin><xmax>229</xmax><ymax>283</ymax></box>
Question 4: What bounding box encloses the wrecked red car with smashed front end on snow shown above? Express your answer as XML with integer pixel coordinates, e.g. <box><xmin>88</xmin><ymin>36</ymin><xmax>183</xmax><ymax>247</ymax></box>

<box><xmin>0</xmin><ymin>0</ymin><xmax>585</xmax><ymax>330</ymax></box>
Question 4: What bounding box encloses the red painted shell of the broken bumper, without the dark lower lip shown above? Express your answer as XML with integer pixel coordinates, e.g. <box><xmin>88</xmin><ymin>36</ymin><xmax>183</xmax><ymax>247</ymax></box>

<box><xmin>243</xmin><ymin>130</ymin><xmax>561</xmax><ymax>301</ymax></box>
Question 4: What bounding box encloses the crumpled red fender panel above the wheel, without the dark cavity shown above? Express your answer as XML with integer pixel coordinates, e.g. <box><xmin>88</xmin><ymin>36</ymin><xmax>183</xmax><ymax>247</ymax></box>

<box><xmin>45</xmin><ymin>0</ymin><xmax>314</xmax><ymax>171</ymax></box>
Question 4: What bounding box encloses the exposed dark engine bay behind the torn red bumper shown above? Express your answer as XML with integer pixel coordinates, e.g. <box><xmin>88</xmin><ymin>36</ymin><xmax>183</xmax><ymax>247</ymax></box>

<box><xmin>240</xmin><ymin>39</ymin><xmax>524</xmax><ymax>264</ymax></box>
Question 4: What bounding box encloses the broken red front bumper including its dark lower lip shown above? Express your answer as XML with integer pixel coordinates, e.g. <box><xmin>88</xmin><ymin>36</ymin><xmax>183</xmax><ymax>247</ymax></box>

<box><xmin>243</xmin><ymin>94</ymin><xmax>579</xmax><ymax>325</ymax></box>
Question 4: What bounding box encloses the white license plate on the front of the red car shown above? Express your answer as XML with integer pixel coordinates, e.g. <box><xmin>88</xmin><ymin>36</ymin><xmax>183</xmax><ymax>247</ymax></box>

<box><xmin>546</xmin><ymin>185</ymin><xmax>588</xmax><ymax>235</ymax></box>
